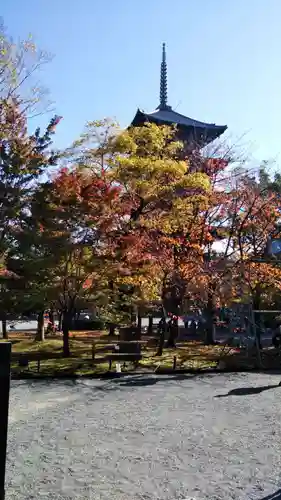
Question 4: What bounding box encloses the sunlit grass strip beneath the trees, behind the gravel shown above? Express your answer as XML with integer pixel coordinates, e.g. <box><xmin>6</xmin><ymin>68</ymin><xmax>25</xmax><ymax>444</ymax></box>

<box><xmin>1</xmin><ymin>331</ymin><xmax>234</xmax><ymax>376</ymax></box>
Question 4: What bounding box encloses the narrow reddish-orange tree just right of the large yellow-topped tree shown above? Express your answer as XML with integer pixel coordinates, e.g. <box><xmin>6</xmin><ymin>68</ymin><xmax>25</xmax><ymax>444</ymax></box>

<box><xmin>183</xmin><ymin>156</ymin><xmax>233</xmax><ymax>344</ymax></box>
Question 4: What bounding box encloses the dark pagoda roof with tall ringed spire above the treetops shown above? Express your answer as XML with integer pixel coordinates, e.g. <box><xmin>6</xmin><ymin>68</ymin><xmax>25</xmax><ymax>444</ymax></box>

<box><xmin>131</xmin><ymin>43</ymin><xmax>227</xmax><ymax>150</ymax></box>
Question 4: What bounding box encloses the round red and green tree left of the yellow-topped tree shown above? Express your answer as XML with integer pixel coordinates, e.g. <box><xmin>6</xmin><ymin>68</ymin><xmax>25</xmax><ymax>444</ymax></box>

<box><xmin>10</xmin><ymin>162</ymin><xmax>122</xmax><ymax>356</ymax></box>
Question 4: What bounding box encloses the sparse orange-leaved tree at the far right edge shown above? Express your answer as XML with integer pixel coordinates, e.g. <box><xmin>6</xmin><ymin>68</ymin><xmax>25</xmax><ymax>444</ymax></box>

<box><xmin>229</xmin><ymin>170</ymin><xmax>281</xmax><ymax>346</ymax></box>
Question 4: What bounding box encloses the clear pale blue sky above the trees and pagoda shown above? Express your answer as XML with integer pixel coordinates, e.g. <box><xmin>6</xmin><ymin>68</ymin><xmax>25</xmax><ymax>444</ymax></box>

<box><xmin>0</xmin><ymin>0</ymin><xmax>281</xmax><ymax>159</ymax></box>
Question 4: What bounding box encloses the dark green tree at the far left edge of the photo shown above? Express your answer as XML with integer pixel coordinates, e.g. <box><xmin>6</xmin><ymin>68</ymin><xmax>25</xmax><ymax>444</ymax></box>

<box><xmin>0</xmin><ymin>98</ymin><xmax>60</xmax><ymax>338</ymax></box>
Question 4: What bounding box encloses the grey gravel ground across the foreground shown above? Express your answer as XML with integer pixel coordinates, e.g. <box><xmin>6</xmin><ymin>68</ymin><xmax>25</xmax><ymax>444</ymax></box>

<box><xmin>6</xmin><ymin>374</ymin><xmax>281</xmax><ymax>500</ymax></box>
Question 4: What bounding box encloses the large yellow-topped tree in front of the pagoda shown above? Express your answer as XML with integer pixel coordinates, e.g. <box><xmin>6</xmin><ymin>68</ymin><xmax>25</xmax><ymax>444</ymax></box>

<box><xmin>104</xmin><ymin>124</ymin><xmax>210</xmax><ymax>345</ymax></box>
